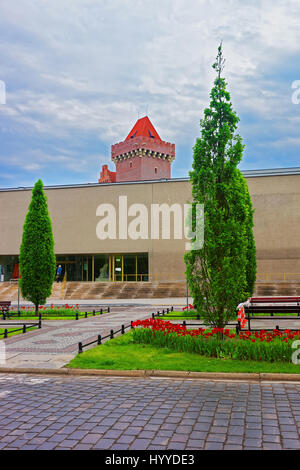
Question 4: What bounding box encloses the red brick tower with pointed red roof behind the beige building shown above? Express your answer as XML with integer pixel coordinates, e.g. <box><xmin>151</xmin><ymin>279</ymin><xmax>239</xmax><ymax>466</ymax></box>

<box><xmin>111</xmin><ymin>116</ymin><xmax>175</xmax><ymax>183</ymax></box>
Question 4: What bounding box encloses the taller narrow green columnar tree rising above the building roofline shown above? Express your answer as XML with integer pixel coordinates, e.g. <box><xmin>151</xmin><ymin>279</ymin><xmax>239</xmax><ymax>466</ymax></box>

<box><xmin>185</xmin><ymin>44</ymin><xmax>256</xmax><ymax>328</ymax></box>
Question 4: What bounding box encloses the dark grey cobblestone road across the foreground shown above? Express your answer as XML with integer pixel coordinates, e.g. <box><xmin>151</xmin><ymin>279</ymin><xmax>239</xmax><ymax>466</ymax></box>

<box><xmin>0</xmin><ymin>374</ymin><xmax>300</xmax><ymax>450</ymax></box>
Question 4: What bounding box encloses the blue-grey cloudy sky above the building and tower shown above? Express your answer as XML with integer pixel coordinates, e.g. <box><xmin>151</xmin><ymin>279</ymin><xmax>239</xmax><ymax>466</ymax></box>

<box><xmin>0</xmin><ymin>0</ymin><xmax>300</xmax><ymax>187</ymax></box>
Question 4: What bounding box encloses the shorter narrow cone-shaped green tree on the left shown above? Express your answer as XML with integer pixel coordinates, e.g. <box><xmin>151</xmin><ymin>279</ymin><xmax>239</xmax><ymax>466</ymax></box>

<box><xmin>20</xmin><ymin>180</ymin><xmax>56</xmax><ymax>315</ymax></box>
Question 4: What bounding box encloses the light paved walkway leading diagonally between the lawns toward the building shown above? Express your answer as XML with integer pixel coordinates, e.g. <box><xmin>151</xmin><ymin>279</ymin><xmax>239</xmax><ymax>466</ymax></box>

<box><xmin>2</xmin><ymin>306</ymin><xmax>161</xmax><ymax>368</ymax></box>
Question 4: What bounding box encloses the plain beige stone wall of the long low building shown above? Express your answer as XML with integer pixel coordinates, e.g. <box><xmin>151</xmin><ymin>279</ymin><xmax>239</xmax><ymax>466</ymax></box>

<box><xmin>0</xmin><ymin>175</ymin><xmax>300</xmax><ymax>280</ymax></box>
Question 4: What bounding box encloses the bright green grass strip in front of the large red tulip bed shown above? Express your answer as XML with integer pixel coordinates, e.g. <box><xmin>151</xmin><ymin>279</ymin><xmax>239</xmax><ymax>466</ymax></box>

<box><xmin>66</xmin><ymin>332</ymin><xmax>300</xmax><ymax>374</ymax></box>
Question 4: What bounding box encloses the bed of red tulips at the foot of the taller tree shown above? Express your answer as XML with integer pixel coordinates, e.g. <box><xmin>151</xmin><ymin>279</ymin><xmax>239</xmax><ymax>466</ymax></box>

<box><xmin>133</xmin><ymin>319</ymin><xmax>300</xmax><ymax>362</ymax></box>
